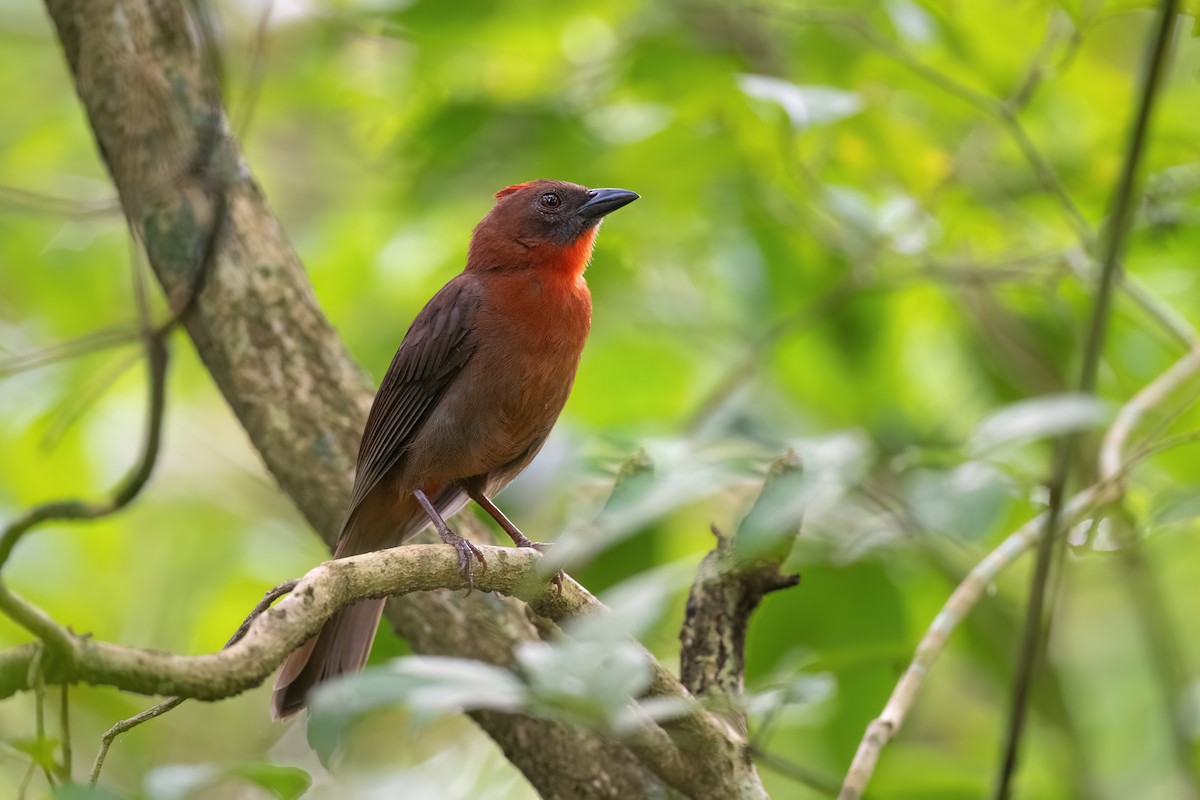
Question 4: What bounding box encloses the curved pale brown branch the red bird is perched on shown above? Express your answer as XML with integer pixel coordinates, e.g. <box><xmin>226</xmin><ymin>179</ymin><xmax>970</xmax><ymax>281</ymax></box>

<box><xmin>0</xmin><ymin>545</ymin><xmax>766</xmax><ymax>798</ymax></box>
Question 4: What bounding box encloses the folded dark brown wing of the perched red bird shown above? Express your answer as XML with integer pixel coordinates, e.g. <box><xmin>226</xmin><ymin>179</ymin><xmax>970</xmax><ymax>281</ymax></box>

<box><xmin>343</xmin><ymin>275</ymin><xmax>480</xmax><ymax>535</ymax></box>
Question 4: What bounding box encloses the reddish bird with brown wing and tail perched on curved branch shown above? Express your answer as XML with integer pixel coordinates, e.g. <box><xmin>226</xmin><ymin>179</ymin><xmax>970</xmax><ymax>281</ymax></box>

<box><xmin>271</xmin><ymin>180</ymin><xmax>638</xmax><ymax>720</ymax></box>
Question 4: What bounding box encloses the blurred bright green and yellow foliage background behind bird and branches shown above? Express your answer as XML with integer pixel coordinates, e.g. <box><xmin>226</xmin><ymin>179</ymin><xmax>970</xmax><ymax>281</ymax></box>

<box><xmin>0</xmin><ymin>0</ymin><xmax>1200</xmax><ymax>799</ymax></box>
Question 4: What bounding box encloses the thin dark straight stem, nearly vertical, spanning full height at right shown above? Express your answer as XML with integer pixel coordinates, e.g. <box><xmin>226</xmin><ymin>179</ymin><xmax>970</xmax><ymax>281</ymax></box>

<box><xmin>995</xmin><ymin>0</ymin><xmax>1177</xmax><ymax>800</ymax></box>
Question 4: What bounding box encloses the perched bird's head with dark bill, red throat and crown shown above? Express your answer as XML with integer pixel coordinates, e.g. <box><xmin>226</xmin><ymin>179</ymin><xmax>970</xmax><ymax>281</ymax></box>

<box><xmin>467</xmin><ymin>180</ymin><xmax>638</xmax><ymax>275</ymax></box>
